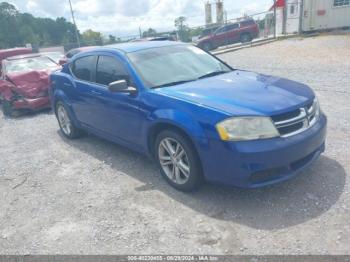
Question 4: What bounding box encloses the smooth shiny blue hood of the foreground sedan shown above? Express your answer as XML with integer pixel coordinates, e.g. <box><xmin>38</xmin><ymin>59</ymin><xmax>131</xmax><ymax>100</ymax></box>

<box><xmin>155</xmin><ymin>70</ymin><xmax>315</xmax><ymax>116</ymax></box>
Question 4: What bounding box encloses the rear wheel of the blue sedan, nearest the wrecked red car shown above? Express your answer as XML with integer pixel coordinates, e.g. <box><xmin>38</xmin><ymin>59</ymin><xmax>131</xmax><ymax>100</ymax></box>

<box><xmin>56</xmin><ymin>102</ymin><xmax>82</xmax><ymax>139</ymax></box>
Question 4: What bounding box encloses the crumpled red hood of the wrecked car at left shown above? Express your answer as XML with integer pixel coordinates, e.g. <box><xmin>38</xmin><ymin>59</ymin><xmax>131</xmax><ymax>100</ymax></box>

<box><xmin>6</xmin><ymin>71</ymin><xmax>50</xmax><ymax>98</ymax></box>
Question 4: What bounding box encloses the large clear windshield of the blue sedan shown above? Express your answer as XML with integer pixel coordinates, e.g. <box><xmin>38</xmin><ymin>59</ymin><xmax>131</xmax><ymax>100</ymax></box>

<box><xmin>128</xmin><ymin>45</ymin><xmax>231</xmax><ymax>88</ymax></box>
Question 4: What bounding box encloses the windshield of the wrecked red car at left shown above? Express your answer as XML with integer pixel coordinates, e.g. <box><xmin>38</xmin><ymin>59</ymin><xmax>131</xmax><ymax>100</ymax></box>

<box><xmin>4</xmin><ymin>56</ymin><xmax>58</xmax><ymax>74</ymax></box>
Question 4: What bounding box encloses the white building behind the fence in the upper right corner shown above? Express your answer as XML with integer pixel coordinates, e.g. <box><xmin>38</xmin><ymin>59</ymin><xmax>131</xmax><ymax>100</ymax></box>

<box><xmin>270</xmin><ymin>0</ymin><xmax>350</xmax><ymax>35</ymax></box>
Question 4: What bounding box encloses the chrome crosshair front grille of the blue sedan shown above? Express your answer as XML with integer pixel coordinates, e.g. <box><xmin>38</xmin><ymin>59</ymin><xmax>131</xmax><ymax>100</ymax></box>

<box><xmin>271</xmin><ymin>100</ymin><xmax>319</xmax><ymax>137</ymax></box>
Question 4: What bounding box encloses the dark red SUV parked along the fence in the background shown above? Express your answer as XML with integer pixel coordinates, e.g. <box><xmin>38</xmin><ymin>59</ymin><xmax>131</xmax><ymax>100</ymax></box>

<box><xmin>197</xmin><ymin>19</ymin><xmax>259</xmax><ymax>51</ymax></box>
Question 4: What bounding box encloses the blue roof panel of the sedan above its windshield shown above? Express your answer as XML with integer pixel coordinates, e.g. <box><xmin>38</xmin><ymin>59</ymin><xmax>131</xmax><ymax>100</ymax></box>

<box><xmin>102</xmin><ymin>41</ymin><xmax>184</xmax><ymax>53</ymax></box>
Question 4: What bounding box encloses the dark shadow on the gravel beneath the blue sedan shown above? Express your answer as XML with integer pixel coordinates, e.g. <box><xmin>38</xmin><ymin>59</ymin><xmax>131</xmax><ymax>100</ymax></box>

<box><xmin>58</xmin><ymin>132</ymin><xmax>346</xmax><ymax>230</ymax></box>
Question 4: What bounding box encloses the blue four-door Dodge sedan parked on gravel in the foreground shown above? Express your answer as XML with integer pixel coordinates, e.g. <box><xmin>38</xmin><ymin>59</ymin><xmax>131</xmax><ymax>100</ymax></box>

<box><xmin>50</xmin><ymin>42</ymin><xmax>327</xmax><ymax>191</ymax></box>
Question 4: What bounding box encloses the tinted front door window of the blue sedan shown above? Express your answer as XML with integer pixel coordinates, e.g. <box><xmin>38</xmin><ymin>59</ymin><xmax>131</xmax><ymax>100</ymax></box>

<box><xmin>96</xmin><ymin>56</ymin><xmax>130</xmax><ymax>85</ymax></box>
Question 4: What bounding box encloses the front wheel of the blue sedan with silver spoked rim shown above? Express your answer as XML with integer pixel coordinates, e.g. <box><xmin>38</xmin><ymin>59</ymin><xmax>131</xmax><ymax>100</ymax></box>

<box><xmin>155</xmin><ymin>130</ymin><xmax>203</xmax><ymax>192</ymax></box>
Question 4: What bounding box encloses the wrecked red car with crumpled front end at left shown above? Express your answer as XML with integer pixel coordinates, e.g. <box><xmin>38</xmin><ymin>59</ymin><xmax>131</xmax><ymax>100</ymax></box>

<box><xmin>0</xmin><ymin>54</ymin><xmax>60</xmax><ymax>116</ymax></box>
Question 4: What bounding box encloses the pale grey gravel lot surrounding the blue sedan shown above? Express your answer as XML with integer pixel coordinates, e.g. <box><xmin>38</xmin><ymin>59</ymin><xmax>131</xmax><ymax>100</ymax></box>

<box><xmin>0</xmin><ymin>35</ymin><xmax>350</xmax><ymax>254</ymax></box>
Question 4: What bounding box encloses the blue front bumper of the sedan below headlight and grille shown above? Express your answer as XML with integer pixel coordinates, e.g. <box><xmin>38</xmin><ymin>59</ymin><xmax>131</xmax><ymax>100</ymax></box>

<box><xmin>199</xmin><ymin>114</ymin><xmax>327</xmax><ymax>188</ymax></box>
